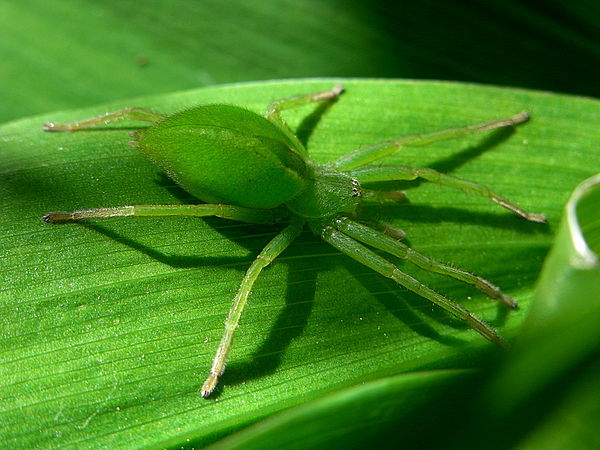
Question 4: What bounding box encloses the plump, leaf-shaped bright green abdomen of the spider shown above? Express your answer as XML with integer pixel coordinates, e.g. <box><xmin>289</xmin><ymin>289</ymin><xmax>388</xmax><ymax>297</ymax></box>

<box><xmin>133</xmin><ymin>105</ymin><xmax>306</xmax><ymax>208</ymax></box>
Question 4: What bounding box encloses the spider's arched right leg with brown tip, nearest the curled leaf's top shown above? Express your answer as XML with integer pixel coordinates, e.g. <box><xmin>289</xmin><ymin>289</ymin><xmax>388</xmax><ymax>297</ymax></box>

<box><xmin>348</xmin><ymin>166</ymin><xmax>546</xmax><ymax>222</ymax></box>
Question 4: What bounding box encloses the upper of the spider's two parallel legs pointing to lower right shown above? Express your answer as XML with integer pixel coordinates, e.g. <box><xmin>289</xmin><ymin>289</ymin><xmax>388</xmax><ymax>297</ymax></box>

<box><xmin>333</xmin><ymin>217</ymin><xmax>517</xmax><ymax>308</ymax></box>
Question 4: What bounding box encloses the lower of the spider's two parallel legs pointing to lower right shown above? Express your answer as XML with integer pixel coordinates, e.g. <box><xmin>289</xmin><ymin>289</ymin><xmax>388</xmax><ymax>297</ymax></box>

<box><xmin>321</xmin><ymin>226</ymin><xmax>508</xmax><ymax>347</ymax></box>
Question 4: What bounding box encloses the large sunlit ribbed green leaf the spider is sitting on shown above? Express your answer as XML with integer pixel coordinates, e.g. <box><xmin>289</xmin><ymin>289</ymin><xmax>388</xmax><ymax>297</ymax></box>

<box><xmin>0</xmin><ymin>80</ymin><xmax>600</xmax><ymax>447</ymax></box>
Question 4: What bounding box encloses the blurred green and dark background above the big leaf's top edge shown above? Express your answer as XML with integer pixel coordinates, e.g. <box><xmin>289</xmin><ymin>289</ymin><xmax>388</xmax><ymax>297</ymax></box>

<box><xmin>0</xmin><ymin>0</ymin><xmax>600</xmax><ymax>121</ymax></box>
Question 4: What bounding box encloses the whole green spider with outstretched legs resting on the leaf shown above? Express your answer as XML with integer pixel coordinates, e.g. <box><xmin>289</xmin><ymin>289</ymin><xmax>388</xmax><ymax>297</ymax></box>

<box><xmin>44</xmin><ymin>85</ymin><xmax>546</xmax><ymax>398</ymax></box>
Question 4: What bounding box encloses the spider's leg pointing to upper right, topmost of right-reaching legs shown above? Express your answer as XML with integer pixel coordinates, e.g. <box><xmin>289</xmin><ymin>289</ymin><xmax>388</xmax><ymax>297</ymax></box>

<box><xmin>332</xmin><ymin>111</ymin><xmax>529</xmax><ymax>170</ymax></box>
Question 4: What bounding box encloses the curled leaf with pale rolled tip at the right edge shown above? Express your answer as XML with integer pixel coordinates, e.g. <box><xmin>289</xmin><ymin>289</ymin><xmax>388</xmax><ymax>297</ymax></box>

<box><xmin>496</xmin><ymin>174</ymin><xmax>600</xmax><ymax>411</ymax></box>
